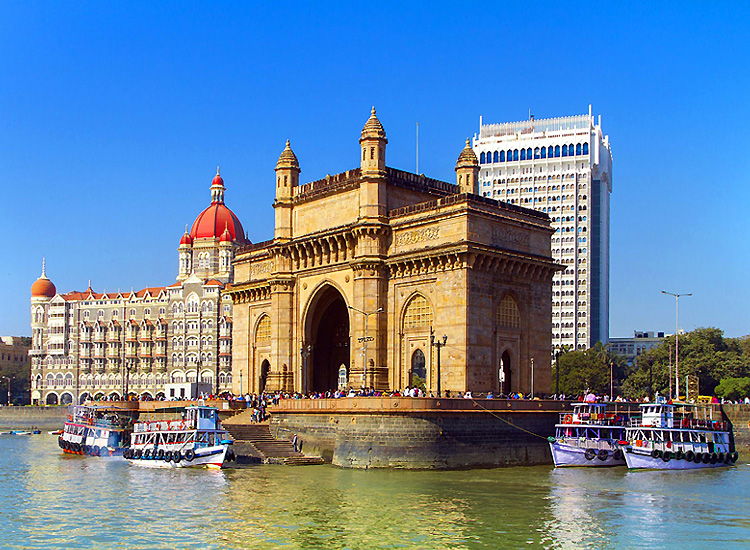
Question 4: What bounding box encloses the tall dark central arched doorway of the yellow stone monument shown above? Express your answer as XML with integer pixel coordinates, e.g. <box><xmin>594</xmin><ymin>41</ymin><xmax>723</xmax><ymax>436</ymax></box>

<box><xmin>305</xmin><ymin>286</ymin><xmax>352</xmax><ymax>392</ymax></box>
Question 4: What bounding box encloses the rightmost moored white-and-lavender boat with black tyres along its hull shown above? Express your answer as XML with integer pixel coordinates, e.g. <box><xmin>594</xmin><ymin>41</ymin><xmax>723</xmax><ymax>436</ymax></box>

<box><xmin>624</xmin><ymin>397</ymin><xmax>738</xmax><ymax>470</ymax></box>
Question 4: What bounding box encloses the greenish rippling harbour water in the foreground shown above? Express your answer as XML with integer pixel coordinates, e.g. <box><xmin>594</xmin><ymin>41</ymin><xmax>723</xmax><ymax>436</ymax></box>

<box><xmin>0</xmin><ymin>434</ymin><xmax>750</xmax><ymax>549</ymax></box>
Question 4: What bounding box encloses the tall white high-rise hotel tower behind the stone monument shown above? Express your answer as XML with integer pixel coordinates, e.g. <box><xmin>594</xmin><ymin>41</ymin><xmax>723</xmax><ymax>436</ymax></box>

<box><xmin>473</xmin><ymin>106</ymin><xmax>612</xmax><ymax>349</ymax></box>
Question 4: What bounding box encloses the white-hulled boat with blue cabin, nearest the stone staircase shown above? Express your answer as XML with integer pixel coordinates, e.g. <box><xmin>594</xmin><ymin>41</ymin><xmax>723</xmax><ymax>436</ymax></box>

<box><xmin>123</xmin><ymin>405</ymin><xmax>234</xmax><ymax>468</ymax></box>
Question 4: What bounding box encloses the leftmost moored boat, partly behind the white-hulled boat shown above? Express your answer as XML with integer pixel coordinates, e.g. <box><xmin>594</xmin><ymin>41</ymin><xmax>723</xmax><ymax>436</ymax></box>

<box><xmin>57</xmin><ymin>405</ymin><xmax>133</xmax><ymax>456</ymax></box>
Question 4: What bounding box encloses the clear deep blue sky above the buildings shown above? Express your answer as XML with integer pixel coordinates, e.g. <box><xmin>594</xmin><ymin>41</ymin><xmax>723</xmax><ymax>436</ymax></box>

<box><xmin>0</xmin><ymin>1</ymin><xmax>750</xmax><ymax>336</ymax></box>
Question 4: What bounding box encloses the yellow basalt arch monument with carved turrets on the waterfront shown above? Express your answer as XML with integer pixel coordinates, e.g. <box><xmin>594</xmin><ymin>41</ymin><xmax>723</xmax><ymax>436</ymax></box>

<box><xmin>229</xmin><ymin>109</ymin><xmax>559</xmax><ymax>394</ymax></box>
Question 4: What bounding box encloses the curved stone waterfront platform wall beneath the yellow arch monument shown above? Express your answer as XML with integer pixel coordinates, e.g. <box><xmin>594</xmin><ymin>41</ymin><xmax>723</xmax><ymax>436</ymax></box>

<box><xmin>271</xmin><ymin>397</ymin><xmax>569</xmax><ymax>469</ymax></box>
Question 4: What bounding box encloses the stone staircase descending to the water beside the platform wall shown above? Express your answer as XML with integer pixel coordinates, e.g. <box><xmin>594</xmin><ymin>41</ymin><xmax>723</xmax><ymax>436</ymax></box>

<box><xmin>223</xmin><ymin>414</ymin><xmax>325</xmax><ymax>466</ymax></box>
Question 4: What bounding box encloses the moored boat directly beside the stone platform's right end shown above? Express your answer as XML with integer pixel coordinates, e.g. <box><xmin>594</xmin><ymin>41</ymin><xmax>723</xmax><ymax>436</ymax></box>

<box><xmin>547</xmin><ymin>403</ymin><xmax>630</xmax><ymax>468</ymax></box>
